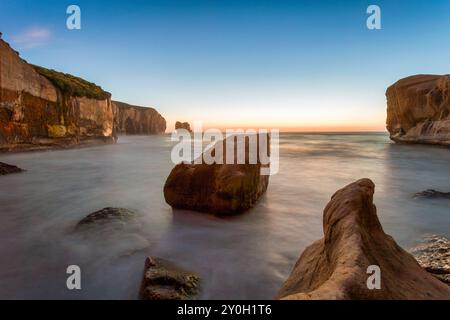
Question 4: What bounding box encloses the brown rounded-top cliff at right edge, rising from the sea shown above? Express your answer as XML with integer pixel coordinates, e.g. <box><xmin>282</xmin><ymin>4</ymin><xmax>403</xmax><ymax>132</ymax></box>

<box><xmin>386</xmin><ymin>75</ymin><xmax>450</xmax><ymax>145</ymax></box>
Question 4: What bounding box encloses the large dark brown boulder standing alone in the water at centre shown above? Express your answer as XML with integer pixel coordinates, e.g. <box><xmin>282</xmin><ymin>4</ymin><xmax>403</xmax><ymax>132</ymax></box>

<box><xmin>164</xmin><ymin>137</ymin><xmax>270</xmax><ymax>215</ymax></box>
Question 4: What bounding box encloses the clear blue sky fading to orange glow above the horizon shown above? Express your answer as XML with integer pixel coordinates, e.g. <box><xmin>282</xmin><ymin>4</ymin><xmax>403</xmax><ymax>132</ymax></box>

<box><xmin>0</xmin><ymin>0</ymin><xmax>450</xmax><ymax>131</ymax></box>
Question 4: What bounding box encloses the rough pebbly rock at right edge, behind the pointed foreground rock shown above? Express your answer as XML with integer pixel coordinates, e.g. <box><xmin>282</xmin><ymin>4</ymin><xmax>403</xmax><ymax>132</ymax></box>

<box><xmin>411</xmin><ymin>235</ymin><xmax>450</xmax><ymax>285</ymax></box>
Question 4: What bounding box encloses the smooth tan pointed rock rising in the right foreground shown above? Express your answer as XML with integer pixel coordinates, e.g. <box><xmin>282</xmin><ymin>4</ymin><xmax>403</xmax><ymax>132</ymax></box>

<box><xmin>277</xmin><ymin>179</ymin><xmax>450</xmax><ymax>300</ymax></box>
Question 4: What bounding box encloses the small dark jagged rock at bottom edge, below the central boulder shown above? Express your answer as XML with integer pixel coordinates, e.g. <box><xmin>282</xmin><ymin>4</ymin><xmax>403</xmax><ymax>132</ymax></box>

<box><xmin>139</xmin><ymin>257</ymin><xmax>200</xmax><ymax>300</ymax></box>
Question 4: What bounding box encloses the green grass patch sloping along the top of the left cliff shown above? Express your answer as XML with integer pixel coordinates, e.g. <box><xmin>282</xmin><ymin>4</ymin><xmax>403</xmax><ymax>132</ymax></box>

<box><xmin>33</xmin><ymin>65</ymin><xmax>111</xmax><ymax>100</ymax></box>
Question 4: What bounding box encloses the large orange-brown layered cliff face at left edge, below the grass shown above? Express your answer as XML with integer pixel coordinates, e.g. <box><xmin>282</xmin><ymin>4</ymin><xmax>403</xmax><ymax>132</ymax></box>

<box><xmin>0</xmin><ymin>39</ymin><xmax>114</xmax><ymax>151</ymax></box>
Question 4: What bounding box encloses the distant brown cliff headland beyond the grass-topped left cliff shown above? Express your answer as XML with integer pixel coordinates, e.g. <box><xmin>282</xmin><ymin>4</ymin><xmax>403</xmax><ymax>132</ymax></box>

<box><xmin>113</xmin><ymin>101</ymin><xmax>166</xmax><ymax>134</ymax></box>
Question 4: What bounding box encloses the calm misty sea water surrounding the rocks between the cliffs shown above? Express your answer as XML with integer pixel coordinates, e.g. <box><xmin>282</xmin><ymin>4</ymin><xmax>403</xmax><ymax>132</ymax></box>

<box><xmin>0</xmin><ymin>133</ymin><xmax>450</xmax><ymax>299</ymax></box>
